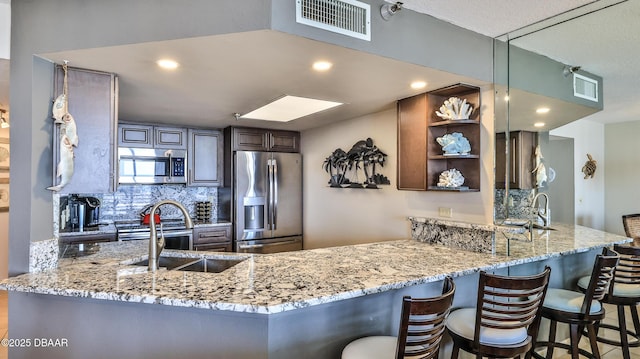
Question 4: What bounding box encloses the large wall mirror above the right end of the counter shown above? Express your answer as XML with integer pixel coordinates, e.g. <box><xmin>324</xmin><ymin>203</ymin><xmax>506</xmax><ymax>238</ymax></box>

<box><xmin>494</xmin><ymin>0</ymin><xmax>640</xmax><ymax>234</ymax></box>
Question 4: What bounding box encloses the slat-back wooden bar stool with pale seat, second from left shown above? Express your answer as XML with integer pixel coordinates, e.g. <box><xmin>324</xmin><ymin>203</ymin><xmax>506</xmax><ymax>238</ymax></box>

<box><xmin>447</xmin><ymin>267</ymin><xmax>551</xmax><ymax>359</ymax></box>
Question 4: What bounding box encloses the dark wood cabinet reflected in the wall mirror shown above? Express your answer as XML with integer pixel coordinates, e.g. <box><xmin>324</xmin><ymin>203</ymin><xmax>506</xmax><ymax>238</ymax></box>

<box><xmin>496</xmin><ymin>131</ymin><xmax>537</xmax><ymax>189</ymax></box>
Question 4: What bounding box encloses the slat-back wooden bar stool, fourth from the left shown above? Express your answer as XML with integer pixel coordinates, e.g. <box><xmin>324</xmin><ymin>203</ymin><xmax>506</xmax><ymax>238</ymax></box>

<box><xmin>578</xmin><ymin>245</ymin><xmax>640</xmax><ymax>359</ymax></box>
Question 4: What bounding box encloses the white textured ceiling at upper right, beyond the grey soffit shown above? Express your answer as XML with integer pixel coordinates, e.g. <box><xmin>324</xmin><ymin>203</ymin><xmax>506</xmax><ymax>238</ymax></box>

<box><xmin>403</xmin><ymin>0</ymin><xmax>640</xmax><ymax>123</ymax></box>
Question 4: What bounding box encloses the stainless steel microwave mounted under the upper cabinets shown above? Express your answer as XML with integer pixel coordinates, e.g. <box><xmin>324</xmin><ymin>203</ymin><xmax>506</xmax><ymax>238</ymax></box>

<box><xmin>118</xmin><ymin>147</ymin><xmax>187</xmax><ymax>184</ymax></box>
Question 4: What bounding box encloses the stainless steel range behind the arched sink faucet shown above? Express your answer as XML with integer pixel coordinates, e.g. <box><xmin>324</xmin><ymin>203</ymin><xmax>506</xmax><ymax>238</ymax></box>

<box><xmin>114</xmin><ymin>219</ymin><xmax>193</xmax><ymax>250</ymax></box>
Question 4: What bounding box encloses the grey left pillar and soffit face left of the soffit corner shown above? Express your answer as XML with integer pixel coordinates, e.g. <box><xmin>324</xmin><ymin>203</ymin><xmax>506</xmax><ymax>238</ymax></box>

<box><xmin>9</xmin><ymin>0</ymin><xmax>270</xmax><ymax>275</ymax></box>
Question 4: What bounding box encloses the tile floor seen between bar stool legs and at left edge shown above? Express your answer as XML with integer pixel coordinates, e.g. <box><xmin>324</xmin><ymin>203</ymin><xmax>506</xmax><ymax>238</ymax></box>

<box><xmin>0</xmin><ymin>290</ymin><xmax>640</xmax><ymax>359</ymax></box>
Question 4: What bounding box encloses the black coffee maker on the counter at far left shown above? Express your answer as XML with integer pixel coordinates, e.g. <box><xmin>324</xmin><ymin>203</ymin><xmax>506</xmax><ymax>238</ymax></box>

<box><xmin>60</xmin><ymin>194</ymin><xmax>100</xmax><ymax>232</ymax></box>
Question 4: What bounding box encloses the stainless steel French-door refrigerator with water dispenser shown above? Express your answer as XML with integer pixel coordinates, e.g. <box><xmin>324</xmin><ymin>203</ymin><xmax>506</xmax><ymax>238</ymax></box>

<box><xmin>232</xmin><ymin>151</ymin><xmax>302</xmax><ymax>253</ymax></box>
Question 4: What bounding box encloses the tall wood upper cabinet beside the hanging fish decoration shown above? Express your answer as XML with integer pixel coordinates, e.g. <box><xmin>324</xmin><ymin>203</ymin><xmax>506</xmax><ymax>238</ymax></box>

<box><xmin>51</xmin><ymin>65</ymin><xmax>118</xmax><ymax>194</ymax></box>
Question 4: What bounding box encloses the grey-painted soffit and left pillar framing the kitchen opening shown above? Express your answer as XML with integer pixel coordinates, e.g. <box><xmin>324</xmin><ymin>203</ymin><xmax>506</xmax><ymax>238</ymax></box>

<box><xmin>9</xmin><ymin>0</ymin><xmax>500</xmax><ymax>275</ymax></box>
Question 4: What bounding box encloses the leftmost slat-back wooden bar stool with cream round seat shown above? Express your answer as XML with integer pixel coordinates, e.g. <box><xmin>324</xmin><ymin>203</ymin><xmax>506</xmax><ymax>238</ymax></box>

<box><xmin>342</xmin><ymin>277</ymin><xmax>456</xmax><ymax>359</ymax></box>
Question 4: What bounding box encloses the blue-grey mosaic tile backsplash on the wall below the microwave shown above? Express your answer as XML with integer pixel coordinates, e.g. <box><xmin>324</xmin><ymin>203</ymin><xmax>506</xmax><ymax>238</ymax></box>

<box><xmin>54</xmin><ymin>185</ymin><xmax>218</xmax><ymax>222</ymax></box>
